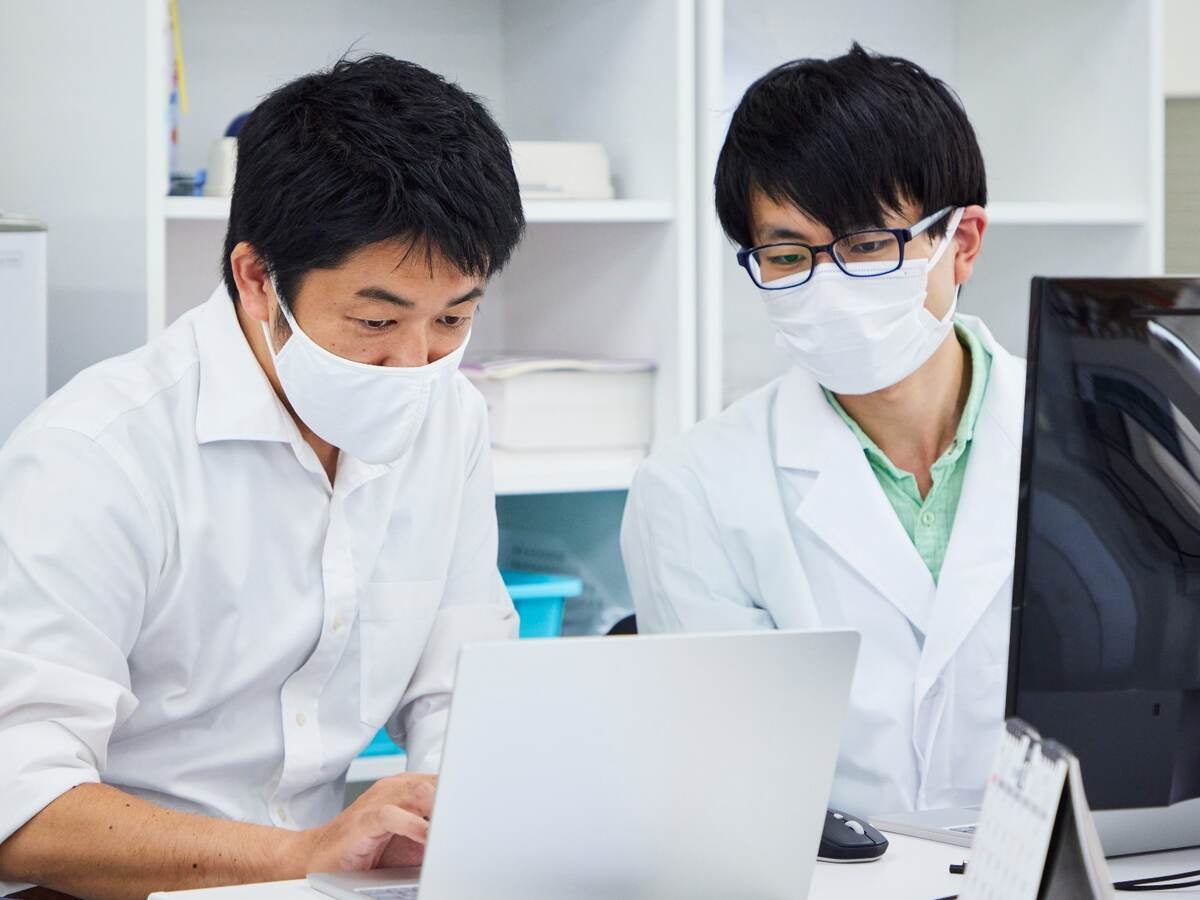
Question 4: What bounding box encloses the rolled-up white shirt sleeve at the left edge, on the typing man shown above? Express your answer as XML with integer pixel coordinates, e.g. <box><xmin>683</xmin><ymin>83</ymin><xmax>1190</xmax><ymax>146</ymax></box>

<box><xmin>0</xmin><ymin>427</ymin><xmax>162</xmax><ymax>849</ymax></box>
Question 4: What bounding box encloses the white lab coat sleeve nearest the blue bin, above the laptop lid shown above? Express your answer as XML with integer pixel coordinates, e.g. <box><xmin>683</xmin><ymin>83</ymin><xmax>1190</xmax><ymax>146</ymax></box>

<box><xmin>620</xmin><ymin>457</ymin><xmax>775</xmax><ymax>634</ymax></box>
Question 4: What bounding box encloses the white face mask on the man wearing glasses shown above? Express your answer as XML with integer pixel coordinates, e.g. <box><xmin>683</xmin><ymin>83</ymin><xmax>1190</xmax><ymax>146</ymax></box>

<box><xmin>762</xmin><ymin>209</ymin><xmax>962</xmax><ymax>395</ymax></box>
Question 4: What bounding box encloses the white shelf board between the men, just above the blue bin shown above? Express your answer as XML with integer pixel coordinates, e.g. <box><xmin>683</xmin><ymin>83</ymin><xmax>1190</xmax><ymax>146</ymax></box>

<box><xmin>492</xmin><ymin>450</ymin><xmax>646</xmax><ymax>494</ymax></box>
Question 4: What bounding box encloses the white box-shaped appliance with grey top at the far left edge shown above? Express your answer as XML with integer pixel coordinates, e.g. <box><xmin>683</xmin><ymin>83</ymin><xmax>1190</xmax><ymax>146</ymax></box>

<box><xmin>0</xmin><ymin>215</ymin><xmax>46</xmax><ymax>444</ymax></box>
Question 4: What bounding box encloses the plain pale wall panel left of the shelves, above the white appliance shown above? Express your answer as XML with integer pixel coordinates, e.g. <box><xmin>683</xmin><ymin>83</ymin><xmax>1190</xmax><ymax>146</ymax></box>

<box><xmin>0</xmin><ymin>0</ymin><xmax>146</xmax><ymax>390</ymax></box>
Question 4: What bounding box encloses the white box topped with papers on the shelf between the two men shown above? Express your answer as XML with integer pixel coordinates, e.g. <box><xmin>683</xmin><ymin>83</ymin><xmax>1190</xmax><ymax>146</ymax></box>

<box><xmin>463</xmin><ymin>356</ymin><xmax>654</xmax><ymax>450</ymax></box>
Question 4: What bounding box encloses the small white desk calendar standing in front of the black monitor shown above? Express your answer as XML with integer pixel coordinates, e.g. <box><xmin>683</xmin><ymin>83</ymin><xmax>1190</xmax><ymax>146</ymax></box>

<box><xmin>960</xmin><ymin>719</ymin><xmax>1112</xmax><ymax>900</ymax></box>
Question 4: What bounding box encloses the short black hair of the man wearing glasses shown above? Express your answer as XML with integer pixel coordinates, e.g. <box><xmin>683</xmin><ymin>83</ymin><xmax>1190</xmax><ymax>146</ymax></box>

<box><xmin>714</xmin><ymin>43</ymin><xmax>988</xmax><ymax>247</ymax></box>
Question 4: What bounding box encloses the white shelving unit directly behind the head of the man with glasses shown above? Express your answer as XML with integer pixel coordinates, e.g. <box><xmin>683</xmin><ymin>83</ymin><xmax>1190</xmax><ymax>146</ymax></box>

<box><xmin>697</xmin><ymin>0</ymin><xmax>1163</xmax><ymax>415</ymax></box>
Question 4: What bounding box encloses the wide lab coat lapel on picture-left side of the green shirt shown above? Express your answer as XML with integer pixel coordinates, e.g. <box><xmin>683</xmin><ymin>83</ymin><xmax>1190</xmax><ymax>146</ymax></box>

<box><xmin>774</xmin><ymin>370</ymin><xmax>934</xmax><ymax>631</ymax></box>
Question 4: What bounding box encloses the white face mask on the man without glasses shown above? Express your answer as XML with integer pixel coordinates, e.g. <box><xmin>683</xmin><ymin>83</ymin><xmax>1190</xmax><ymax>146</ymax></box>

<box><xmin>263</xmin><ymin>278</ymin><xmax>470</xmax><ymax>463</ymax></box>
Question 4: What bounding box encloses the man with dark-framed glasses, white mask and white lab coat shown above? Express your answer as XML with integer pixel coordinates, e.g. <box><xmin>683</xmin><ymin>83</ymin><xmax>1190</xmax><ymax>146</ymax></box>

<box><xmin>622</xmin><ymin>44</ymin><xmax>1025</xmax><ymax>815</ymax></box>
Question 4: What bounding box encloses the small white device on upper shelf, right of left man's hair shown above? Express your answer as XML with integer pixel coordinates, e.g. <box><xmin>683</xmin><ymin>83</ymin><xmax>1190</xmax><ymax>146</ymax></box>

<box><xmin>511</xmin><ymin>140</ymin><xmax>613</xmax><ymax>200</ymax></box>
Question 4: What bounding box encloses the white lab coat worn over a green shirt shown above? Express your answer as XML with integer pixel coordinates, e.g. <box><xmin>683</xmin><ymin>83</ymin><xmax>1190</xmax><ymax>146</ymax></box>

<box><xmin>622</xmin><ymin>317</ymin><xmax>1025</xmax><ymax>815</ymax></box>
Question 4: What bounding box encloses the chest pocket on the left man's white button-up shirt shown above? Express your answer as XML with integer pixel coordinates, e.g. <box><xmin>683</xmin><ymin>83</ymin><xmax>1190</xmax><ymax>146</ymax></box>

<box><xmin>359</xmin><ymin>578</ymin><xmax>445</xmax><ymax>728</ymax></box>
